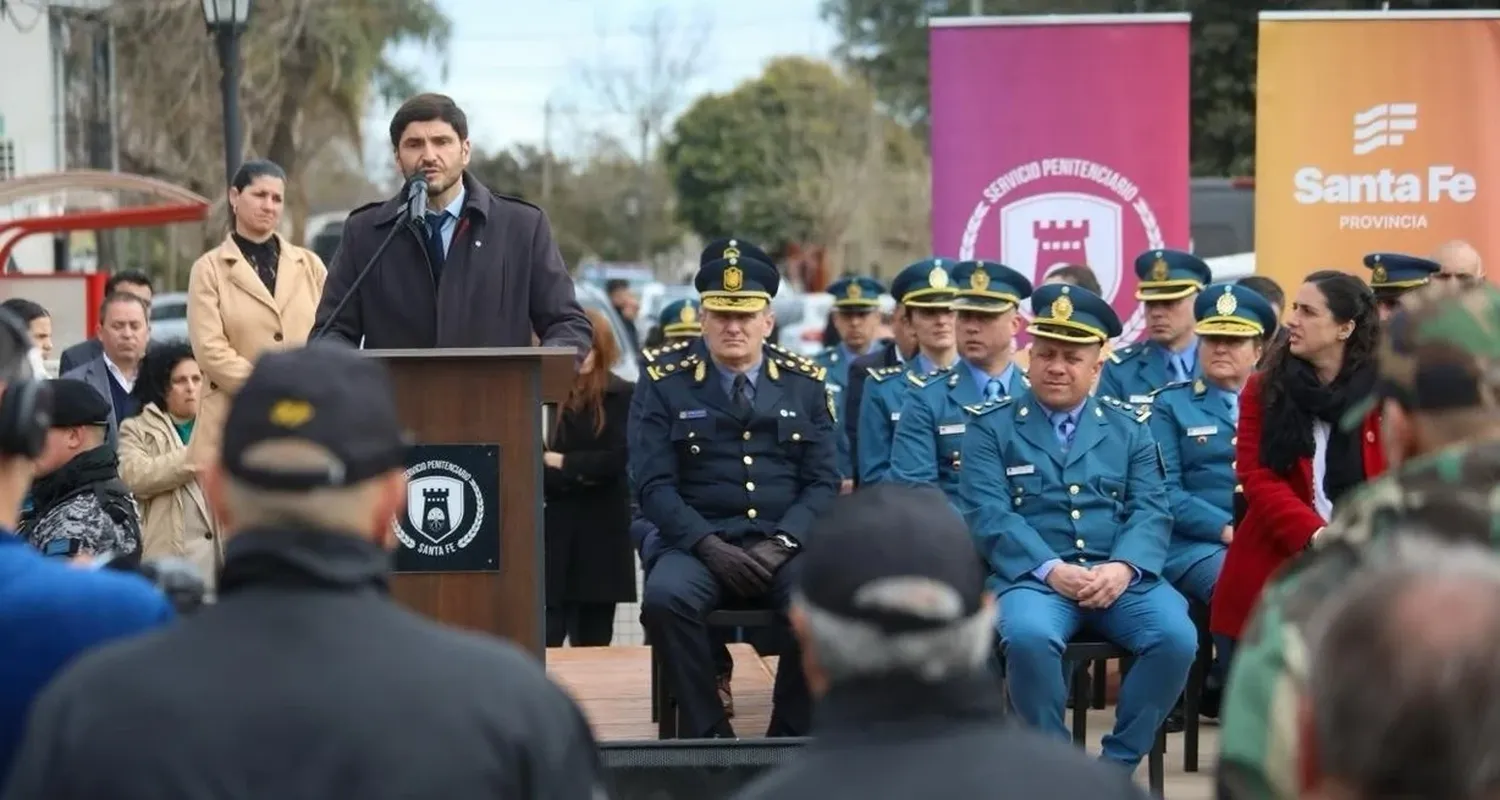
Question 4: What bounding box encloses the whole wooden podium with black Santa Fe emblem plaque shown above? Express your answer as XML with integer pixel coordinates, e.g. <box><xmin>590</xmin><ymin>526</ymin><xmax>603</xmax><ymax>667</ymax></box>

<box><xmin>366</xmin><ymin>347</ymin><xmax>576</xmax><ymax>659</ymax></box>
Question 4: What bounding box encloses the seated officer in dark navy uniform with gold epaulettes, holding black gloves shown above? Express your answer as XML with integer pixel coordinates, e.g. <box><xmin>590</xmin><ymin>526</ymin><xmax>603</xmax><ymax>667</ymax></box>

<box><xmin>630</xmin><ymin>257</ymin><xmax>839</xmax><ymax>737</ymax></box>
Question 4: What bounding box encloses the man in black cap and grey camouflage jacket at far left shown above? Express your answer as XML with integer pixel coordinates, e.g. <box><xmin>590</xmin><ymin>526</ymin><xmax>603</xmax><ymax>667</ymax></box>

<box><xmin>20</xmin><ymin>378</ymin><xmax>141</xmax><ymax>563</ymax></box>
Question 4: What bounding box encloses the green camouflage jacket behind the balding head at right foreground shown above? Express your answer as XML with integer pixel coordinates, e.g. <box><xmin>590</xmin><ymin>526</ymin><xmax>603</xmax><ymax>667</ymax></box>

<box><xmin>1220</xmin><ymin>441</ymin><xmax>1500</xmax><ymax>800</ymax></box>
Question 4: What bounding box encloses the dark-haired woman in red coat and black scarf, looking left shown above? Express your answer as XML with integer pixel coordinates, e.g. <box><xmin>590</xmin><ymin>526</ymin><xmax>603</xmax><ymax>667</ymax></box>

<box><xmin>1209</xmin><ymin>270</ymin><xmax>1385</xmax><ymax>642</ymax></box>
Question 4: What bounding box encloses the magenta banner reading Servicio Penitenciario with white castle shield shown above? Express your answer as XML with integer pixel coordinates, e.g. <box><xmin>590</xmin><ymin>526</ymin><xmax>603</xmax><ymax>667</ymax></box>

<box><xmin>930</xmin><ymin>14</ymin><xmax>1190</xmax><ymax>342</ymax></box>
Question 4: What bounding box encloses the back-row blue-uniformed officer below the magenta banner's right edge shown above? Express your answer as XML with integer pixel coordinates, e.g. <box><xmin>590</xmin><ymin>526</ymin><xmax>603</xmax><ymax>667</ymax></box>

<box><xmin>1098</xmin><ymin>249</ymin><xmax>1214</xmax><ymax>405</ymax></box>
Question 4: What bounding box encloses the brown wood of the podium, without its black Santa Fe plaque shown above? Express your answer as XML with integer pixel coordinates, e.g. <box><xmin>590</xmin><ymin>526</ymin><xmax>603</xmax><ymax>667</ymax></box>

<box><xmin>369</xmin><ymin>348</ymin><xmax>573</xmax><ymax>659</ymax></box>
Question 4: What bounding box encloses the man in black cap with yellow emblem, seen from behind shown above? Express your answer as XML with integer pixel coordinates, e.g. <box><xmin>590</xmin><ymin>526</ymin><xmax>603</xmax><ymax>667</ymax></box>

<box><xmin>6</xmin><ymin>344</ymin><xmax>603</xmax><ymax>800</ymax></box>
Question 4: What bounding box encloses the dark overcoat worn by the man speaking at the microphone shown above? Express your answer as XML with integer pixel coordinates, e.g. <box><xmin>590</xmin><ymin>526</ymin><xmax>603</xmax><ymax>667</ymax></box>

<box><xmin>314</xmin><ymin>173</ymin><xmax>593</xmax><ymax>360</ymax></box>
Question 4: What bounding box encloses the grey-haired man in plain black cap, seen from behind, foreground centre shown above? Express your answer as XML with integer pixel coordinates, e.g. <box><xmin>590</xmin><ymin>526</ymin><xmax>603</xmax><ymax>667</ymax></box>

<box><xmin>737</xmin><ymin>483</ymin><xmax>1145</xmax><ymax>800</ymax></box>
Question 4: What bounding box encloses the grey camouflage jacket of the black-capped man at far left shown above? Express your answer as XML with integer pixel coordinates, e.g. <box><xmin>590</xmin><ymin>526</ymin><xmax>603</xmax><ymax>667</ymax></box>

<box><xmin>20</xmin><ymin>482</ymin><xmax>141</xmax><ymax>555</ymax></box>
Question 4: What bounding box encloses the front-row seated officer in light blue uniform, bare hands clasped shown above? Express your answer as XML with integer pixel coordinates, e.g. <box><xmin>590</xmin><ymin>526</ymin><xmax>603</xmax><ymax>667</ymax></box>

<box><xmin>959</xmin><ymin>284</ymin><xmax>1197</xmax><ymax>770</ymax></box>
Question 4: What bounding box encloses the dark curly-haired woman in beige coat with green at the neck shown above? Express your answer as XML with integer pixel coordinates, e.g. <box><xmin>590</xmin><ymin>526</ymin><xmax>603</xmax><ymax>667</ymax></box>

<box><xmin>119</xmin><ymin>341</ymin><xmax>224</xmax><ymax>587</ymax></box>
